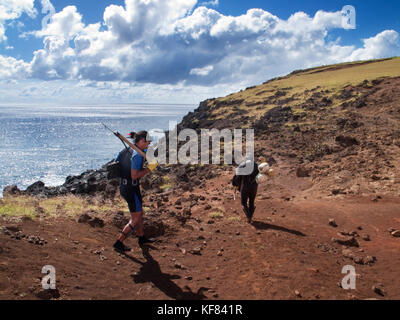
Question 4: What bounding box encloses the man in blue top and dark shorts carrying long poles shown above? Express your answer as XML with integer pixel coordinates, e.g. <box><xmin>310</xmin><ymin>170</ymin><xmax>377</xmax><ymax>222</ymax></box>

<box><xmin>114</xmin><ymin>131</ymin><xmax>158</xmax><ymax>252</ymax></box>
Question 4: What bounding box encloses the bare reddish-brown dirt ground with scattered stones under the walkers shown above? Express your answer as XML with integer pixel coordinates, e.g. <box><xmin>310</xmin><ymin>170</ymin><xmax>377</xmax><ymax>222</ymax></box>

<box><xmin>0</xmin><ymin>172</ymin><xmax>400</xmax><ymax>300</ymax></box>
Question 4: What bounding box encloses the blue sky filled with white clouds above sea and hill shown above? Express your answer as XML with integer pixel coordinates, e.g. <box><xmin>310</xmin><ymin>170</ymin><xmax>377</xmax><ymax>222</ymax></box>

<box><xmin>0</xmin><ymin>0</ymin><xmax>400</xmax><ymax>105</ymax></box>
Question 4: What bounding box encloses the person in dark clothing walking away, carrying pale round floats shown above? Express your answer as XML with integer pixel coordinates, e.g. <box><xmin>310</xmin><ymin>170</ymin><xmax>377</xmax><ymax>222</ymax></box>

<box><xmin>232</xmin><ymin>160</ymin><xmax>259</xmax><ymax>223</ymax></box>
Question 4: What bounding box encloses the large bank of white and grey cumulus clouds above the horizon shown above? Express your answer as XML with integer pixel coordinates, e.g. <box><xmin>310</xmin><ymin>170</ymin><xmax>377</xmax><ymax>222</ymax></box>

<box><xmin>0</xmin><ymin>0</ymin><xmax>400</xmax><ymax>95</ymax></box>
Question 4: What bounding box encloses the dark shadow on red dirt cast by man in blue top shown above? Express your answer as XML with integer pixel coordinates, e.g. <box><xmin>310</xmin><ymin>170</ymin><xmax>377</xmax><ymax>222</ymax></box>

<box><xmin>126</xmin><ymin>246</ymin><xmax>209</xmax><ymax>300</ymax></box>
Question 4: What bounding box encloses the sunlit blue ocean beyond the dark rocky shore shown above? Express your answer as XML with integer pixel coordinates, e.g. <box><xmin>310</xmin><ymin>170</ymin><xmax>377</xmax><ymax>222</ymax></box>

<box><xmin>0</xmin><ymin>104</ymin><xmax>197</xmax><ymax>196</ymax></box>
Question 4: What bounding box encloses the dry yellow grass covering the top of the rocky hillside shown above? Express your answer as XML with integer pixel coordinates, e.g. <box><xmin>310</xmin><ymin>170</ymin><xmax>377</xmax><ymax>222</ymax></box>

<box><xmin>205</xmin><ymin>57</ymin><xmax>400</xmax><ymax>126</ymax></box>
